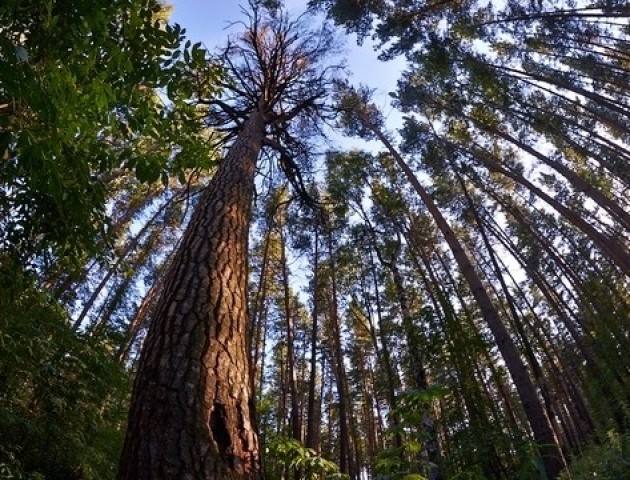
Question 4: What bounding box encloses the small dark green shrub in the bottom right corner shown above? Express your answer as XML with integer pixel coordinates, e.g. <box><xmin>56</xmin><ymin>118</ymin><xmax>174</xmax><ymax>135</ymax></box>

<box><xmin>560</xmin><ymin>431</ymin><xmax>630</xmax><ymax>480</ymax></box>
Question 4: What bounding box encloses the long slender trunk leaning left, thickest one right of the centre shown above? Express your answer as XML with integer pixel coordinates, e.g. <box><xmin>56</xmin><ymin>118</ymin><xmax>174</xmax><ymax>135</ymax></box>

<box><xmin>363</xmin><ymin>118</ymin><xmax>566</xmax><ymax>478</ymax></box>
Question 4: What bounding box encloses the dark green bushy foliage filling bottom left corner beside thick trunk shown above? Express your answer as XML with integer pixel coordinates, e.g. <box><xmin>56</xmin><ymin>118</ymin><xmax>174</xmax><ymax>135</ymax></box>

<box><xmin>0</xmin><ymin>258</ymin><xmax>130</xmax><ymax>479</ymax></box>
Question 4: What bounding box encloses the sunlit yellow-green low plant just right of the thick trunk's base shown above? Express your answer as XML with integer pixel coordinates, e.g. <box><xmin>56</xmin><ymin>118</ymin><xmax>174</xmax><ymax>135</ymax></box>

<box><xmin>266</xmin><ymin>437</ymin><xmax>344</xmax><ymax>480</ymax></box>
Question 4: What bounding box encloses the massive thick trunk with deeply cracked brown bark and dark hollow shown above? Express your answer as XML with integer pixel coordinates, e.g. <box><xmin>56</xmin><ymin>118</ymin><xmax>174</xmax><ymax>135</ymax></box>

<box><xmin>118</xmin><ymin>112</ymin><xmax>264</xmax><ymax>480</ymax></box>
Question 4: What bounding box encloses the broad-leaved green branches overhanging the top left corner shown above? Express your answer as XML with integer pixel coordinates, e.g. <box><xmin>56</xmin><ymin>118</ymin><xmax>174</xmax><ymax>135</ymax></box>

<box><xmin>0</xmin><ymin>0</ymin><xmax>221</xmax><ymax>264</ymax></box>
